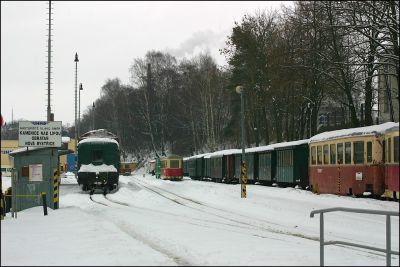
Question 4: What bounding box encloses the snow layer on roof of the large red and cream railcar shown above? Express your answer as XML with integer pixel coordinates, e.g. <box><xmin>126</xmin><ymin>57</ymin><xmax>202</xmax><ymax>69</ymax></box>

<box><xmin>310</xmin><ymin>122</ymin><xmax>399</xmax><ymax>143</ymax></box>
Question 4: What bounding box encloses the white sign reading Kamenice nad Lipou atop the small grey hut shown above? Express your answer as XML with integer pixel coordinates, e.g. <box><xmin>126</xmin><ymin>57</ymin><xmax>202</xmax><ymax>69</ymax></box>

<box><xmin>18</xmin><ymin>121</ymin><xmax>61</xmax><ymax>147</ymax></box>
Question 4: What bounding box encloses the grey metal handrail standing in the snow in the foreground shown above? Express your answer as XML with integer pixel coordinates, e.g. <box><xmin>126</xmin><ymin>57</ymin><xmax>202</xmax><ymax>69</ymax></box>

<box><xmin>310</xmin><ymin>207</ymin><xmax>399</xmax><ymax>266</ymax></box>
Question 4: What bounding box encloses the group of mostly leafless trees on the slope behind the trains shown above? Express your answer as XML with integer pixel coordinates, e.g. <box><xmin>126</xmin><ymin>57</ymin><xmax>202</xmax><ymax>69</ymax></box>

<box><xmin>2</xmin><ymin>1</ymin><xmax>399</xmax><ymax>159</ymax></box>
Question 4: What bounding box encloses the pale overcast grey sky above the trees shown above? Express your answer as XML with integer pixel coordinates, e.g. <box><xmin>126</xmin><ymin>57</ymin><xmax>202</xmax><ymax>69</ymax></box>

<box><xmin>1</xmin><ymin>1</ymin><xmax>291</xmax><ymax>125</ymax></box>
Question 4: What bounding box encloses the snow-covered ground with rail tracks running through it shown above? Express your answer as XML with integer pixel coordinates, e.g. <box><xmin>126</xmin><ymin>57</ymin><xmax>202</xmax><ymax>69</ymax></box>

<box><xmin>1</xmin><ymin>170</ymin><xmax>399</xmax><ymax>266</ymax></box>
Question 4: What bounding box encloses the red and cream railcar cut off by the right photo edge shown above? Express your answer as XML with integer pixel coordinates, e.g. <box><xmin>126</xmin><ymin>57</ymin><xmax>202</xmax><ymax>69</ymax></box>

<box><xmin>384</xmin><ymin>124</ymin><xmax>399</xmax><ymax>200</ymax></box>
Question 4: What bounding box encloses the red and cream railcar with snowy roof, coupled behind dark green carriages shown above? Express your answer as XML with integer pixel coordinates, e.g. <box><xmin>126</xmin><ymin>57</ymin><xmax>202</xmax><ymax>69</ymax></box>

<box><xmin>309</xmin><ymin>122</ymin><xmax>398</xmax><ymax>197</ymax></box>
